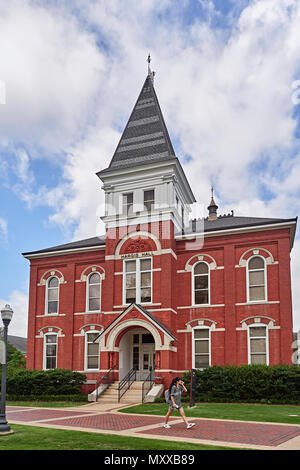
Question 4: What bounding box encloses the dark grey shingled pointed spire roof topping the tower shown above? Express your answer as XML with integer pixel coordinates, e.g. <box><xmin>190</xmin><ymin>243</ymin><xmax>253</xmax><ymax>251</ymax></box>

<box><xmin>101</xmin><ymin>70</ymin><xmax>176</xmax><ymax>173</ymax></box>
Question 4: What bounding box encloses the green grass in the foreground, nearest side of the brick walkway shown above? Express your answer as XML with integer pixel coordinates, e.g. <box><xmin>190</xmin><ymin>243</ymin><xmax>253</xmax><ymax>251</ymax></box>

<box><xmin>0</xmin><ymin>424</ymin><xmax>241</xmax><ymax>451</ymax></box>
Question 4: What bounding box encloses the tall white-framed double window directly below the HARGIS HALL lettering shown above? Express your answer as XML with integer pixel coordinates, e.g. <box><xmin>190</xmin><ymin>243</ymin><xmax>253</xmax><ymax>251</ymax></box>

<box><xmin>123</xmin><ymin>258</ymin><xmax>152</xmax><ymax>304</ymax></box>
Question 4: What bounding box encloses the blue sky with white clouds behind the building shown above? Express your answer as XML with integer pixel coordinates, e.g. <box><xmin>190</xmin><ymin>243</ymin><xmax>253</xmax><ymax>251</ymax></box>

<box><xmin>0</xmin><ymin>0</ymin><xmax>300</xmax><ymax>336</ymax></box>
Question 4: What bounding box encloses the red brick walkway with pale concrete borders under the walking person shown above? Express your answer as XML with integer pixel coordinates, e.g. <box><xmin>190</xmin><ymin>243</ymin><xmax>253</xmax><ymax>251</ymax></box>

<box><xmin>6</xmin><ymin>403</ymin><xmax>300</xmax><ymax>450</ymax></box>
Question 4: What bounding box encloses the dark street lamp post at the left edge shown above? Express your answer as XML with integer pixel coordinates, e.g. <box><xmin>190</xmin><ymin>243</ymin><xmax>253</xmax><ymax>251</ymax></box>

<box><xmin>0</xmin><ymin>304</ymin><xmax>13</xmax><ymax>435</ymax></box>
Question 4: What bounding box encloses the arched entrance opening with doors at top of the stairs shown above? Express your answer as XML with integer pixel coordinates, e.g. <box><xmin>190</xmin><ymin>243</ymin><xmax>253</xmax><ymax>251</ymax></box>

<box><xmin>119</xmin><ymin>327</ymin><xmax>155</xmax><ymax>380</ymax></box>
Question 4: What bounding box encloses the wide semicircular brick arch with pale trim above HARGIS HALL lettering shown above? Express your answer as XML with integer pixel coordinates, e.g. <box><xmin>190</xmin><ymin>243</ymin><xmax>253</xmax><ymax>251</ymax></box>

<box><xmin>115</xmin><ymin>231</ymin><xmax>161</xmax><ymax>256</ymax></box>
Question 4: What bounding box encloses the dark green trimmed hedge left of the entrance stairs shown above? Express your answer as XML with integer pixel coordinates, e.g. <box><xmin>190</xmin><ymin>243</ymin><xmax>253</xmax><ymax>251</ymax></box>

<box><xmin>1</xmin><ymin>367</ymin><xmax>86</xmax><ymax>396</ymax></box>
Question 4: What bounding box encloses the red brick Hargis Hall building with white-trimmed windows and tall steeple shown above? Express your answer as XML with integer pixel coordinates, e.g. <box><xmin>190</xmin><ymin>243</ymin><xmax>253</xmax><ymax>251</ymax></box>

<box><xmin>23</xmin><ymin>70</ymin><xmax>297</xmax><ymax>391</ymax></box>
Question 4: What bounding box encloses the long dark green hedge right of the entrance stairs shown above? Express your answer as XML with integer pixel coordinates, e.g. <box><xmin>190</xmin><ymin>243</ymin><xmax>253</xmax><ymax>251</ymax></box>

<box><xmin>179</xmin><ymin>365</ymin><xmax>300</xmax><ymax>404</ymax></box>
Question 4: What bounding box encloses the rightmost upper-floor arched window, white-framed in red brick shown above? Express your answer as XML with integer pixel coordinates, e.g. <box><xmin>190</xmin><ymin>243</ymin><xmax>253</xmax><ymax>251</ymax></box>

<box><xmin>248</xmin><ymin>256</ymin><xmax>267</xmax><ymax>302</ymax></box>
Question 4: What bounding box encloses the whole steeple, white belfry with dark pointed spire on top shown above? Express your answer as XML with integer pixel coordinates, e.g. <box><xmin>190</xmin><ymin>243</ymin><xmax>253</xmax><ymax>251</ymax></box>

<box><xmin>97</xmin><ymin>60</ymin><xmax>195</xmax><ymax>230</ymax></box>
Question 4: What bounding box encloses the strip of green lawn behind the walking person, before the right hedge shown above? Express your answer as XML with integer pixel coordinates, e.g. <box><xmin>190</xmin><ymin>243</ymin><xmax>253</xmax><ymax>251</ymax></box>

<box><xmin>120</xmin><ymin>403</ymin><xmax>300</xmax><ymax>424</ymax></box>
